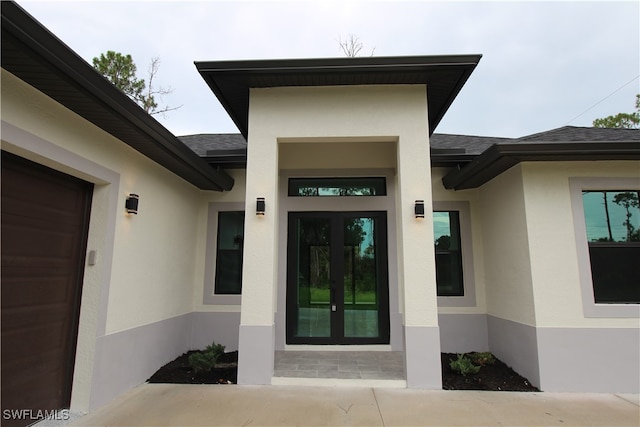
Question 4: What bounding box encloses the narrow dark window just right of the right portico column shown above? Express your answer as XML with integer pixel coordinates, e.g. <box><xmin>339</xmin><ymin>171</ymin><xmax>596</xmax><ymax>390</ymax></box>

<box><xmin>433</xmin><ymin>211</ymin><xmax>464</xmax><ymax>296</ymax></box>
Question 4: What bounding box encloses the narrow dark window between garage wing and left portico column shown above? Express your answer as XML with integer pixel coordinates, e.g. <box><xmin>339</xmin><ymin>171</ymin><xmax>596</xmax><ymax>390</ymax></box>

<box><xmin>215</xmin><ymin>212</ymin><xmax>244</xmax><ymax>295</ymax></box>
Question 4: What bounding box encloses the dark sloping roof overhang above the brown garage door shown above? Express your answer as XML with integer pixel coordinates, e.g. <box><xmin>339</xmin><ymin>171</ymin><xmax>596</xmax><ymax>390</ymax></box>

<box><xmin>2</xmin><ymin>1</ymin><xmax>233</xmax><ymax>191</ymax></box>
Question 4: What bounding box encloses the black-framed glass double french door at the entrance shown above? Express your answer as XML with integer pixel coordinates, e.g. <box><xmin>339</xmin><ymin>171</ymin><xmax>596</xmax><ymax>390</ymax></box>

<box><xmin>287</xmin><ymin>212</ymin><xmax>389</xmax><ymax>344</ymax></box>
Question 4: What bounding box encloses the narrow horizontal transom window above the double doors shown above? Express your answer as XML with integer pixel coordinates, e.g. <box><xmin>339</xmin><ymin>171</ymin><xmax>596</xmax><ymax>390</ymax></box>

<box><xmin>289</xmin><ymin>177</ymin><xmax>387</xmax><ymax>197</ymax></box>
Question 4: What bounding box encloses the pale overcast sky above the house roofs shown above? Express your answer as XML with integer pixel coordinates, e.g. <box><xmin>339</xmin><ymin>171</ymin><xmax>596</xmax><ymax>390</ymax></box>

<box><xmin>18</xmin><ymin>0</ymin><xmax>640</xmax><ymax>137</ymax></box>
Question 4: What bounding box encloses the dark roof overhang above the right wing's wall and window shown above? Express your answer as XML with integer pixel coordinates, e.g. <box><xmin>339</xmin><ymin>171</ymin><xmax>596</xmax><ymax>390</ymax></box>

<box><xmin>442</xmin><ymin>142</ymin><xmax>640</xmax><ymax>190</ymax></box>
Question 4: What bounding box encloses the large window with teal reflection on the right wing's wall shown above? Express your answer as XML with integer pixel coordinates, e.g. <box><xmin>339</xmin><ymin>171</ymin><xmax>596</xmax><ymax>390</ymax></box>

<box><xmin>582</xmin><ymin>190</ymin><xmax>640</xmax><ymax>304</ymax></box>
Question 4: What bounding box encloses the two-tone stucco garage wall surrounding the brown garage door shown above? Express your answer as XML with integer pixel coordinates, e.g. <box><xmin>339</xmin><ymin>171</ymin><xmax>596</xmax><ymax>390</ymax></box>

<box><xmin>2</xmin><ymin>70</ymin><xmax>212</xmax><ymax>411</ymax></box>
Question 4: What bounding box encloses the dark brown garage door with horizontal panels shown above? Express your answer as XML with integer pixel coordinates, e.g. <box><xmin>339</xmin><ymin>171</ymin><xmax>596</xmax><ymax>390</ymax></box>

<box><xmin>1</xmin><ymin>151</ymin><xmax>93</xmax><ymax>425</ymax></box>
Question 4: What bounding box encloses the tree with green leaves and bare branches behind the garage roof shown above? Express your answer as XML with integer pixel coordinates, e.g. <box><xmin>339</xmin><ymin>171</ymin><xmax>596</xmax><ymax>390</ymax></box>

<box><xmin>93</xmin><ymin>50</ymin><xmax>181</xmax><ymax>114</ymax></box>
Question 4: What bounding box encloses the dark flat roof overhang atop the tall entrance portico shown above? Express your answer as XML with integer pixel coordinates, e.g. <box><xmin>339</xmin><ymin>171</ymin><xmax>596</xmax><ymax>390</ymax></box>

<box><xmin>195</xmin><ymin>55</ymin><xmax>482</xmax><ymax>138</ymax></box>
